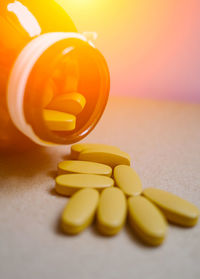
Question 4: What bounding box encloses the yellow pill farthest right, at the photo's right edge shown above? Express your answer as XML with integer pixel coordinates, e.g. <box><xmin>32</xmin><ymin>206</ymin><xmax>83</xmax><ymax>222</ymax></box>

<box><xmin>143</xmin><ymin>188</ymin><xmax>200</xmax><ymax>227</ymax></box>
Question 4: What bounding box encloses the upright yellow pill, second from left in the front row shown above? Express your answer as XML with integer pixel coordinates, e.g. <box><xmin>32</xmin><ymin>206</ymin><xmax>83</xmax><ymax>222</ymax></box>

<box><xmin>97</xmin><ymin>187</ymin><xmax>127</xmax><ymax>235</ymax></box>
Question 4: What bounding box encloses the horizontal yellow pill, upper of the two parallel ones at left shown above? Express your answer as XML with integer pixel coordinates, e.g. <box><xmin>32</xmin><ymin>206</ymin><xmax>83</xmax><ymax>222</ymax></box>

<box><xmin>58</xmin><ymin>161</ymin><xmax>112</xmax><ymax>176</ymax></box>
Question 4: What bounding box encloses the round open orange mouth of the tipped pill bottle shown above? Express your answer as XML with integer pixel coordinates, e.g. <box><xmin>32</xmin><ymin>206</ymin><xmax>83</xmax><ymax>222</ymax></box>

<box><xmin>24</xmin><ymin>35</ymin><xmax>109</xmax><ymax>144</ymax></box>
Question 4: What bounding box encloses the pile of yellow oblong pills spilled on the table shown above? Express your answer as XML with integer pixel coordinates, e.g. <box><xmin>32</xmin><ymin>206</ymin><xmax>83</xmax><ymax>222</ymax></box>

<box><xmin>52</xmin><ymin>143</ymin><xmax>199</xmax><ymax>246</ymax></box>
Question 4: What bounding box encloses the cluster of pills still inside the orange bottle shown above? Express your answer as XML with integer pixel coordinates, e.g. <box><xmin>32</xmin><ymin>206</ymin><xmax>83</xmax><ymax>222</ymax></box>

<box><xmin>43</xmin><ymin>58</ymin><xmax>86</xmax><ymax>131</ymax></box>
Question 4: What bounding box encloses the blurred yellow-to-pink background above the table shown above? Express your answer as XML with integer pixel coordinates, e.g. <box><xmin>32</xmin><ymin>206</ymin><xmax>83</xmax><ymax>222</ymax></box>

<box><xmin>56</xmin><ymin>0</ymin><xmax>200</xmax><ymax>102</ymax></box>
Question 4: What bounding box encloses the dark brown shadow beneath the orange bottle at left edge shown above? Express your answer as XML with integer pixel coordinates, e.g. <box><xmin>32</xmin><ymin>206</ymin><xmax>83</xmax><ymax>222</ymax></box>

<box><xmin>0</xmin><ymin>147</ymin><xmax>53</xmax><ymax>178</ymax></box>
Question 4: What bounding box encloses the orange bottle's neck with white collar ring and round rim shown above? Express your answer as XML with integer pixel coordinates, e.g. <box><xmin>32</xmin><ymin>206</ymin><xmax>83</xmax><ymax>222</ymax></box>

<box><xmin>7</xmin><ymin>32</ymin><xmax>109</xmax><ymax>146</ymax></box>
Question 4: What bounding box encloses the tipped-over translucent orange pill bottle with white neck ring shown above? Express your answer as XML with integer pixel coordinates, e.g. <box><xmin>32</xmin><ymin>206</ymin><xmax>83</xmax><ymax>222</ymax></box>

<box><xmin>0</xmin><ymin>0</ymin><xmax>110</xmax><ymax>151</ymax></box>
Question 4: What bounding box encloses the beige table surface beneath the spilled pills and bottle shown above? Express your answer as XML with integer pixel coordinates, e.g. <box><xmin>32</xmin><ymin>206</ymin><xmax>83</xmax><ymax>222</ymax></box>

<box><xmin>0</xmin><ymin>97</ymin><xmax>200</xmax><ymax>279</ymax></box>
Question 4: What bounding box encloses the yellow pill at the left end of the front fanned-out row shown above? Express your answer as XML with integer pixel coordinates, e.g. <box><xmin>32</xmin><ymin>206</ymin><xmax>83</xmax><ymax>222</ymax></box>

<box><xmin>61</xmin><ymin>189</ymin><xmax>99</xmax><ymax>234</ymax></box>
